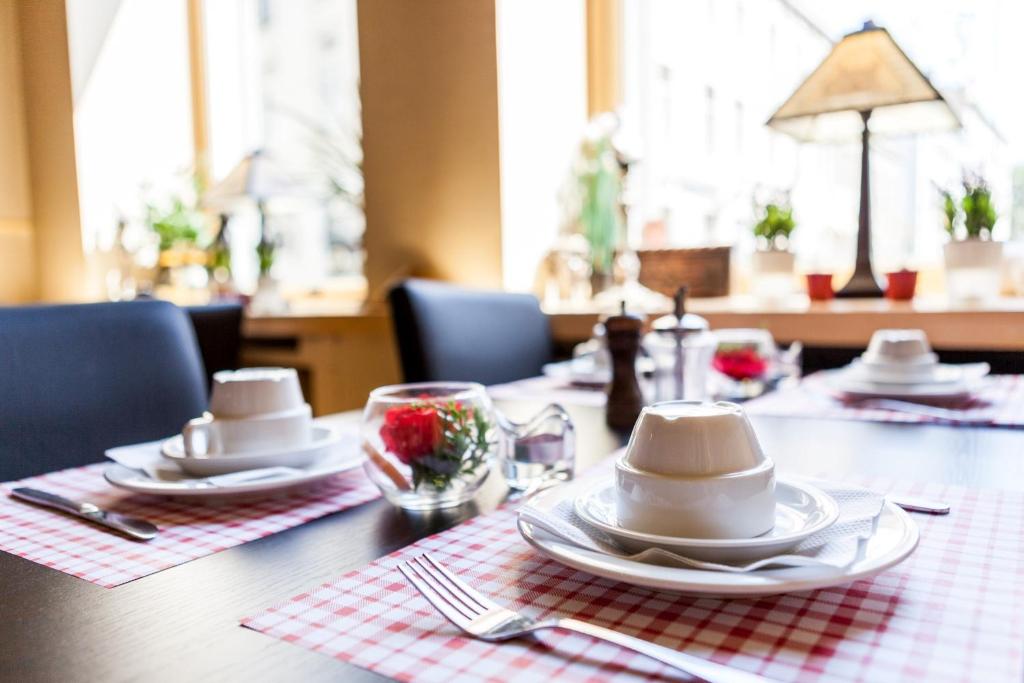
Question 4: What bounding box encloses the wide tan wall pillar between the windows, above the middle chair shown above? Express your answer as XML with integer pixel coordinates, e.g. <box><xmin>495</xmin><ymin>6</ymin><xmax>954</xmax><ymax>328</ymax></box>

<box><xmin>358</xmin><ymin>0</ymin><xmax>502</xmax><ymax>298</ymax></box>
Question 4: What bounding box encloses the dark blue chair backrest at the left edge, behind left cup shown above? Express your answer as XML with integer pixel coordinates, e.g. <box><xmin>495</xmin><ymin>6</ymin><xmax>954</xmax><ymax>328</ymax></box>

<box><xmin>0</xmin><ymin>301</ymin><xmax>207</xmax><ymax>480</ymax></box>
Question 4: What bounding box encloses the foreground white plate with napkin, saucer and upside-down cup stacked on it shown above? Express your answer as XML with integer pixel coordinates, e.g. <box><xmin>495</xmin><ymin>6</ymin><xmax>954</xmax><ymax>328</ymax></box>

<box><xmin>518</xmin><ymin>401</ymin><xmax>918</xmax><ymax>596</ymax></box>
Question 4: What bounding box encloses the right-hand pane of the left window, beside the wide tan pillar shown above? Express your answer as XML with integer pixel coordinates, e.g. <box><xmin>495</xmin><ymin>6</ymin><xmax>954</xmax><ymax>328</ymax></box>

<box><xmin>204</xmin><ymin>0</ymin><xmax>365</xmax><ymax>289</ymax></box>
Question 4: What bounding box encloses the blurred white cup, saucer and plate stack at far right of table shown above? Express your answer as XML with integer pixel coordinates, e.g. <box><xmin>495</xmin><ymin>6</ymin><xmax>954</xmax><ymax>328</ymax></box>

<box><xmin>829</xmin><ymin>330</ymin><xmax>989</xmax><ymax>404</ymax></box>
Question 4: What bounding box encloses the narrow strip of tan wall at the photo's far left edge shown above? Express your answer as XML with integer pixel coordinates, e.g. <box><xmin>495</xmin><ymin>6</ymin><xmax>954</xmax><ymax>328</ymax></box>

<box><xmin>0</xmin><ymin>2</ymin><xmax>36</xmax><ymax>304</ymax></box>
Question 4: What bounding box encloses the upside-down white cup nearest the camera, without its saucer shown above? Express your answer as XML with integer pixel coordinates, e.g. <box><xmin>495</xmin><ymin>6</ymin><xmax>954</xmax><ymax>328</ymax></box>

<box><xmin>615</xmin><ymin>401</ymin><xmax>775</xmax><ymax>539</ymax></box>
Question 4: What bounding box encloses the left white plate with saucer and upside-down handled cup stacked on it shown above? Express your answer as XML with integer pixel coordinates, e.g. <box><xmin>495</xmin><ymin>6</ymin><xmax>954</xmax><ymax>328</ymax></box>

<box><xmin>104</xmin><ymin>368</ymin><xmax>364</xmax><ymax>497</ymax></box>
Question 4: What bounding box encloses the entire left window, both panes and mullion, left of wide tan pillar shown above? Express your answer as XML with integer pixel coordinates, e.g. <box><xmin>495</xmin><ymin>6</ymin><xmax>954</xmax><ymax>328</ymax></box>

<box><xmin>68</xmin><ymin>0</ymin><xmax>365</xmax><ymax>302</ymax></box>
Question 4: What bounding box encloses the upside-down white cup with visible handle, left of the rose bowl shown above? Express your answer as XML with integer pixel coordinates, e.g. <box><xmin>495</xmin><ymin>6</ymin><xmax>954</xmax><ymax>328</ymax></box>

<box><xmin>181</xmin><ymin>368</ymin><xmax>312</xmax><ymax>457</ymax></box>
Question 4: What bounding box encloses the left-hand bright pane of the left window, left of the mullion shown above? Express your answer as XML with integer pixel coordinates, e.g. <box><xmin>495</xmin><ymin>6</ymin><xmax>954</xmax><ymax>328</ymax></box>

<box><xmin>67</xmin><ymin>0</ymin><xmax>193</xmax><ymax>259</ymax></box>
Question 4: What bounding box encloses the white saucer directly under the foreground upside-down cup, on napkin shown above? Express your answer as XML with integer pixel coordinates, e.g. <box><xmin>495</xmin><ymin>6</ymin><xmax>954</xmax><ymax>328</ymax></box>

<box><xmin>574</xmin><ymin>478</ymin><xmax>839</xmax><ymax>563</ymax></box>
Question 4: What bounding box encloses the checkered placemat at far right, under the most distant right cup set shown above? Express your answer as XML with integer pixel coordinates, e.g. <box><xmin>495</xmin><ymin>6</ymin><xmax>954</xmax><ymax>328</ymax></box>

<box><xmin>743</xmin><ymin>373</ymin><xmax>1024</xmax><ymax>427</ymax></box>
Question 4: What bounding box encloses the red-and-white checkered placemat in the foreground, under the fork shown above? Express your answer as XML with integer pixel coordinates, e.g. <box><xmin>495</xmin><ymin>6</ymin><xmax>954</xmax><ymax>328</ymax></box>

<box><xmin>243</xmin><ymin>481</ymin><xmax>1024</xmax><ymax>683</ymax></box>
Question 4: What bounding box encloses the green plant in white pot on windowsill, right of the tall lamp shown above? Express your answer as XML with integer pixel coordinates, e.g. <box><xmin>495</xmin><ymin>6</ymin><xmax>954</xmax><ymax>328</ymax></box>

<box><xmin>942</xmin><ymin>176</ymin><xmax>1002</xmax><ymax>299</ymax></box>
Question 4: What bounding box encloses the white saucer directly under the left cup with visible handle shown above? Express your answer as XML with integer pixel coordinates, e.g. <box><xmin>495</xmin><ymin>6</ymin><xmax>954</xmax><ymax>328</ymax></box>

<box><xmin>160</xmin><ymin>425</ymin><xmax>340</xmax><ymax>477</ymax></box>
